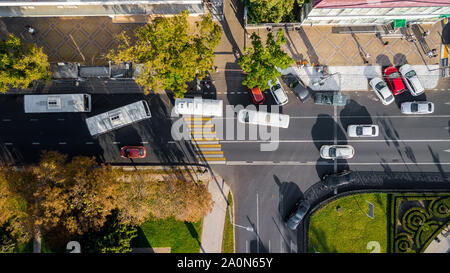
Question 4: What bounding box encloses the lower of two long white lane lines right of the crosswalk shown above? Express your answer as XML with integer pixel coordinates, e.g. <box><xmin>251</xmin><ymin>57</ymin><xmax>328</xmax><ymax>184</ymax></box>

<box><xmin>225</xmin><ymin>160</ymin><xmax>450</xmax><ymax>166</ymax></box>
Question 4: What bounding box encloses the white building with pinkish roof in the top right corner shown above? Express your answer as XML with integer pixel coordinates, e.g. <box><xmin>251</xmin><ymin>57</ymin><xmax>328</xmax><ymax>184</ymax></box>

<box><xmin>302</xmin><ymin>0</ymin><xmax>450</xmax><ymax>26</ymax></box>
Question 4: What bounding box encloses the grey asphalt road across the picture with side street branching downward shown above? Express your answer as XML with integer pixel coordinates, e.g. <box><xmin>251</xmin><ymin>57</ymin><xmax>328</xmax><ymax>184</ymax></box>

<box><xmin>0</xmin><ymin>71</ymin><xmax>450</xmax><ymax>252</ymax></box>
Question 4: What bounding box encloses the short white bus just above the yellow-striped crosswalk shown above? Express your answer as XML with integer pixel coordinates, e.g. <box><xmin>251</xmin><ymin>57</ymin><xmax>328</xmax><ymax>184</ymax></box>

<box><xmin>174</xmin><ymin>97</ymin><xmax>223</xmax><ymax>117</ymax></box>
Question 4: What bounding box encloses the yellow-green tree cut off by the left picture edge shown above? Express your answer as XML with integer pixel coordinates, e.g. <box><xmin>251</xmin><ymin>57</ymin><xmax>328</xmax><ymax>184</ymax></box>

<box><xmin>0</xmin><ymin>34</ymin><xmax>51</xmax><ymax>93</ymax></box>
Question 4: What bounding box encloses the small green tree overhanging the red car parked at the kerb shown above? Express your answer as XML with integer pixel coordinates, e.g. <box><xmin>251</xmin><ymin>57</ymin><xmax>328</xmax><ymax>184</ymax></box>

<box><xmin>238</xmin><ymin>29</ymin><xmax>294</xmax><ymax>90</ymax></box>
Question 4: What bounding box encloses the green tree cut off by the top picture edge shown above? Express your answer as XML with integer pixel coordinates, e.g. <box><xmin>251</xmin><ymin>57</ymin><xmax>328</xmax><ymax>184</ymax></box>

<box><xmin>244</xmin><ymin>0</ymin><xmax>303</xmax><ymax>23</ymax></box>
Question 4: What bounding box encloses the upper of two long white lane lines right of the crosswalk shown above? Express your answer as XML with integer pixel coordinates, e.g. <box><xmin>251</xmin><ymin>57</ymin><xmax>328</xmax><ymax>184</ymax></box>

<box><xmin>220</xmin><ymin>139</ymin><xmax>450</xmax><ymax>143</ymax></box>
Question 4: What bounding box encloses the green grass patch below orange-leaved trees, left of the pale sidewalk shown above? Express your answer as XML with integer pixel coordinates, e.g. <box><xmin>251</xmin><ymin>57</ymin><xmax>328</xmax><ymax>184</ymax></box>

<box><xmin>131</xmin><ymin>218</ymin><xmax>202</xmax><ymax>253</ymax></box>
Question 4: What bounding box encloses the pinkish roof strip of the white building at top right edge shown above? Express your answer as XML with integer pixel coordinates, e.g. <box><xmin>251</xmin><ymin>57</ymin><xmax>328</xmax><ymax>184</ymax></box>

<box><xmin>313</xmin><ymin>0</ymin><xmax>450</xmax><ymax>9</ymax></box>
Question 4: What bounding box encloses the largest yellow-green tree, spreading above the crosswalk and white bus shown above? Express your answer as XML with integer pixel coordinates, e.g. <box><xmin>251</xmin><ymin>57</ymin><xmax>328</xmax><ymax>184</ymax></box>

<box><xmin>108</xmin><ymin>11</ymin><xmax>222</xmax><ymax>97</ymax></box>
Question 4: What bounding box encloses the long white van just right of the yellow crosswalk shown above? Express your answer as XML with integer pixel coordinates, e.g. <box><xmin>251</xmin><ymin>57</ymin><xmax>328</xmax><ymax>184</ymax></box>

<box><xmin>238</xmin><ymin>109</ymin><xmax>289</xmax><ymax>128</ymax></box>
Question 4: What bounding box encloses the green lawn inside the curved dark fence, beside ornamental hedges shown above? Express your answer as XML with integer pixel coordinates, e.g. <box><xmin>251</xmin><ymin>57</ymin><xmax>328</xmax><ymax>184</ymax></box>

<box><xmin>308</xmin><ymin>193</ymin><xmax>389</xmax><ymax>253</ymax></box>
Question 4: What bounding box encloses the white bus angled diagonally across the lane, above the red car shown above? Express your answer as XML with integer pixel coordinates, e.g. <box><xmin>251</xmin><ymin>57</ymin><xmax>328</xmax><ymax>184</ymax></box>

<box><xmin>86</xmin><ymin>100</ymin><xmax>152</xmax><ymax>136</ymax></box>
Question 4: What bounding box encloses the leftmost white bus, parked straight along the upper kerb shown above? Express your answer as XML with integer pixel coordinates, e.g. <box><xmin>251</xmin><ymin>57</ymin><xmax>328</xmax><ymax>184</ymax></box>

<box><xmin>23</xmin><ymin>94</ymin><xmax>91</xmax><ymax>113</ymax></box>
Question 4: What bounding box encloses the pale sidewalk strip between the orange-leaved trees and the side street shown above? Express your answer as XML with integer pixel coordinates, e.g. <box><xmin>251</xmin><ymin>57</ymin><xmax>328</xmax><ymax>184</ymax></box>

<box><xmin>201</xmin><ymin>169</ymin><xmax>230</xmax><ymax>253</ymax></box>
